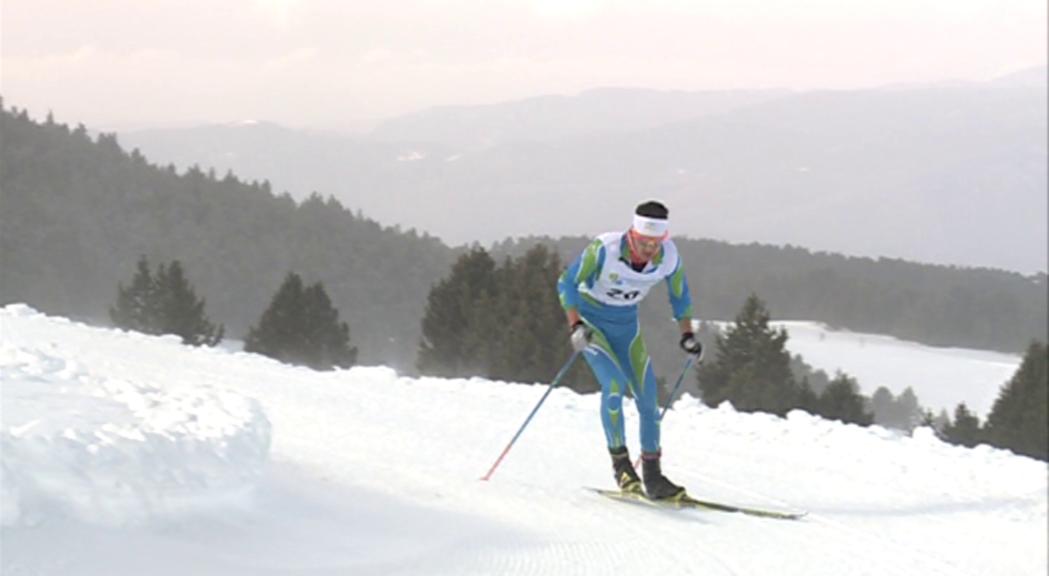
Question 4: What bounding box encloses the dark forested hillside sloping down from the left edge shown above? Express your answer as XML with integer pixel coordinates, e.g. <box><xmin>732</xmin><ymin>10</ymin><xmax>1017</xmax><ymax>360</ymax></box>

<box><xmin>0</xmin><ymin>103</ymin><xmax>453</xmax><ymax>368</ymax></box>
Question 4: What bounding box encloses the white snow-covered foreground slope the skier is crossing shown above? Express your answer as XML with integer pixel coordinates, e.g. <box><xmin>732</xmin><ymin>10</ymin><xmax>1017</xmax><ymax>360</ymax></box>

<box><xmin>0</xmin><ymin>305</ymin><xmax>1049</xmax><ymax>576</ymax></box>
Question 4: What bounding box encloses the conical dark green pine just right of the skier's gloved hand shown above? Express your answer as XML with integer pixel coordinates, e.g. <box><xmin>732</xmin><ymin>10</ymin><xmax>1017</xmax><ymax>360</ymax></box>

<box><xmin>699</xmin><ymin>295</ymin><xmax>801</xmax><ymax>415</ymax></box>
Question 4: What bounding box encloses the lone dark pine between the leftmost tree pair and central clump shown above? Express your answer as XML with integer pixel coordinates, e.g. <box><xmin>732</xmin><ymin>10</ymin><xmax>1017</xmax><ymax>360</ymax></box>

<box><xmin>244</xmin><ymin>272</ymin><xmax>357</xmax><ymax>369</ymax></box>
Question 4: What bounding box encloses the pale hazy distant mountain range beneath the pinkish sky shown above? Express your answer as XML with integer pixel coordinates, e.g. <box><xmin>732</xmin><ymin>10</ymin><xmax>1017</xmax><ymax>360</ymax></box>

<box><xmin>120</xmin><ymin>66</ymin><xmax>1049</xmax><ymax>273</ymax></box>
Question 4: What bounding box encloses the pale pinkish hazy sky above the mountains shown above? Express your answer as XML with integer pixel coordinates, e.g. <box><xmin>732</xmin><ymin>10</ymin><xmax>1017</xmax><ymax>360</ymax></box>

<box><xmin>0</xmin><ymin>0</ymin><xmax>1047</xmax><ymax>129</ymax></box>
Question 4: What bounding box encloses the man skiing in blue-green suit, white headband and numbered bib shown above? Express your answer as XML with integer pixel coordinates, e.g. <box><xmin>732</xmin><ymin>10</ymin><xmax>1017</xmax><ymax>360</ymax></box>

<box><xmin>557</xmin><ymin>201</ymin><xmax>703</xmax><ymax>499</ymax></box>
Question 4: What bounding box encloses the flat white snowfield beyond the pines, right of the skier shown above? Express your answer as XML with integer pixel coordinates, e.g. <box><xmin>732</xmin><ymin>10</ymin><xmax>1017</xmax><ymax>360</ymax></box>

<box><xmin>772</xmin><ymin>321</ymin><xmax>1022</xmax><ymax>419</ymax></box>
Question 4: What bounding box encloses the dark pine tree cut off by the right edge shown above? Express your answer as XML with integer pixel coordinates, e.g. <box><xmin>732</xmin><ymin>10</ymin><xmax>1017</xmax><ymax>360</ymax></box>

<box><xmin>986</xmin><ymin>341</ymin><xmax>1049</xmax><ymax>461</ymax></box>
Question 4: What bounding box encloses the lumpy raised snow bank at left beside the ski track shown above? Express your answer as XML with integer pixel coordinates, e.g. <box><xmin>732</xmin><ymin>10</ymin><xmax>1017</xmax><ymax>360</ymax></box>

<box><xmin>0</xmin><ymin>306</ymin><xmax>270</xmax><ymax>526</ymax></box>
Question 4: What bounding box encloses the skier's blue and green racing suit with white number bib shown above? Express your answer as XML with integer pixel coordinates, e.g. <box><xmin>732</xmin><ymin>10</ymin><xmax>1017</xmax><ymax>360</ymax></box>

<box><xmin>557</xmin><ymin>232</ymin><xmax>692</xmax><ymax>452</ymax></box>
